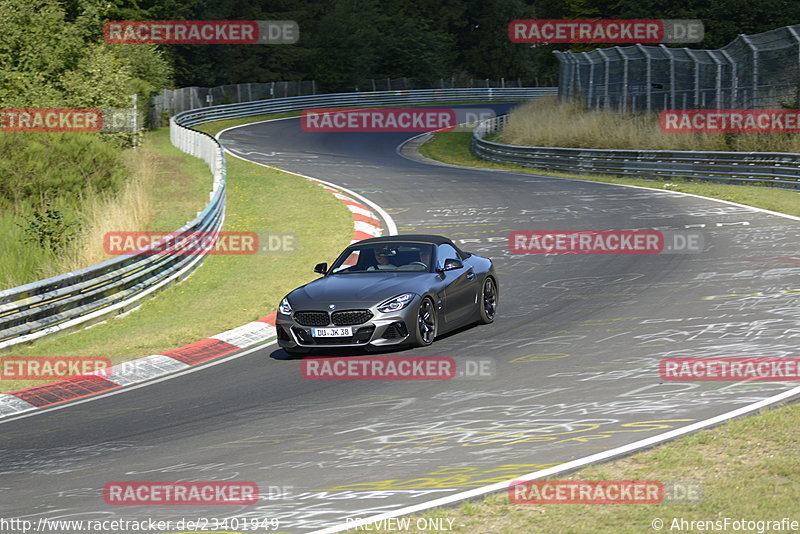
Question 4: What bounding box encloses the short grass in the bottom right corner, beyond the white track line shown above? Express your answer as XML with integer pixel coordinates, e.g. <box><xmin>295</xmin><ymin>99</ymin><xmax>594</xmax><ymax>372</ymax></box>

<box><xmin>349</xmin><ymin>404</ymin><xmax>800</xmax><ymax>534</ymax></box>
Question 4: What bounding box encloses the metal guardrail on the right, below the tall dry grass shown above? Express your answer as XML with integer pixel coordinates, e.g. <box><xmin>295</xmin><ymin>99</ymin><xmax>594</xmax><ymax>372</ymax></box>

<box><xmin>472</xmin><ymin>115</ymin><xmax>800</xmax><ymax>189</ymax></box>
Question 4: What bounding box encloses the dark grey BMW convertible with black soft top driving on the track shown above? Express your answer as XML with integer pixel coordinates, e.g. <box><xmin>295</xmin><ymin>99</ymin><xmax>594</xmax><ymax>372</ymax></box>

<box><xmin>276</xmin><ymin>235</ymin><xmax>497</xmax><ymax>354</ymax></box>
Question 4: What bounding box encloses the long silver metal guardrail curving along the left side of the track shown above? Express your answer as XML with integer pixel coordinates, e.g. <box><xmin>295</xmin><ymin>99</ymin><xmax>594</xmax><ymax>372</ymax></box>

<box><xmin>0</xmin><ymin>88</ymin><xmax>556</xmax><ymax>349</ymax></box>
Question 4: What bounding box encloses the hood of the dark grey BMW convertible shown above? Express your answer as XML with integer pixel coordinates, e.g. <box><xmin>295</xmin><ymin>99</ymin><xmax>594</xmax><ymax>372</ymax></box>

<box><xmin>289</xmin><ymin>272</ymin><xmax>438</xmax><ymax>310</ymax></box>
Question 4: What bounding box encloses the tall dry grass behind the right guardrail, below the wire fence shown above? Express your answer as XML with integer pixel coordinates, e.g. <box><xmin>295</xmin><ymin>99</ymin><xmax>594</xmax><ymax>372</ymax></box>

<box><xmin>499</xmin><ymin>98</ymin><xmax>800</xmax><ymax>152</ymax></box>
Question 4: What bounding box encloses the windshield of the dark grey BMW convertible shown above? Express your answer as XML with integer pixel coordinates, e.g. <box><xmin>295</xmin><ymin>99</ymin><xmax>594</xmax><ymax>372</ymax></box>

<box><xmin>330</xmin><ymin>242</ymin><xmax>433</xmax><ymax>274</ymax></box>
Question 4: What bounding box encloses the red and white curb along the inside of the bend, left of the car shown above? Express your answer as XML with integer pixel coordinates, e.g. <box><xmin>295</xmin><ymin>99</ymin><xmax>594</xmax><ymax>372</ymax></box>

<box><xmin>0</xmin><ymin>178</ymin><xmax>396</xmax><ymax>419</ymax></box>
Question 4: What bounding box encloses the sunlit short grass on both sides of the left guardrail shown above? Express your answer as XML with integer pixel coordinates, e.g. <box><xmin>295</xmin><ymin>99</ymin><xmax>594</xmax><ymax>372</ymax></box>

<box><xmin>0</xmin><ymin>124</ymin><xmax>353</xmax><ymax>391</ymax></box>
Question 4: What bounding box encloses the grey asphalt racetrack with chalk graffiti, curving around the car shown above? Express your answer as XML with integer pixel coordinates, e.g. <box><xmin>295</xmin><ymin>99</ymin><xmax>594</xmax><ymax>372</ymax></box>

<box><xmin>0</xmin><ymin>106</ymin><xmax>800</xmax><ymax>532</ymax></box>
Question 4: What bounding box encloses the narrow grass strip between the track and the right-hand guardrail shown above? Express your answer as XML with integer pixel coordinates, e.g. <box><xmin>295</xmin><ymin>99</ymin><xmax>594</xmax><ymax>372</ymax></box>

<box><xmin>420</xmin><ymin>132</ymin><xmax>800</xmax><ymax>215</ymax></box>
